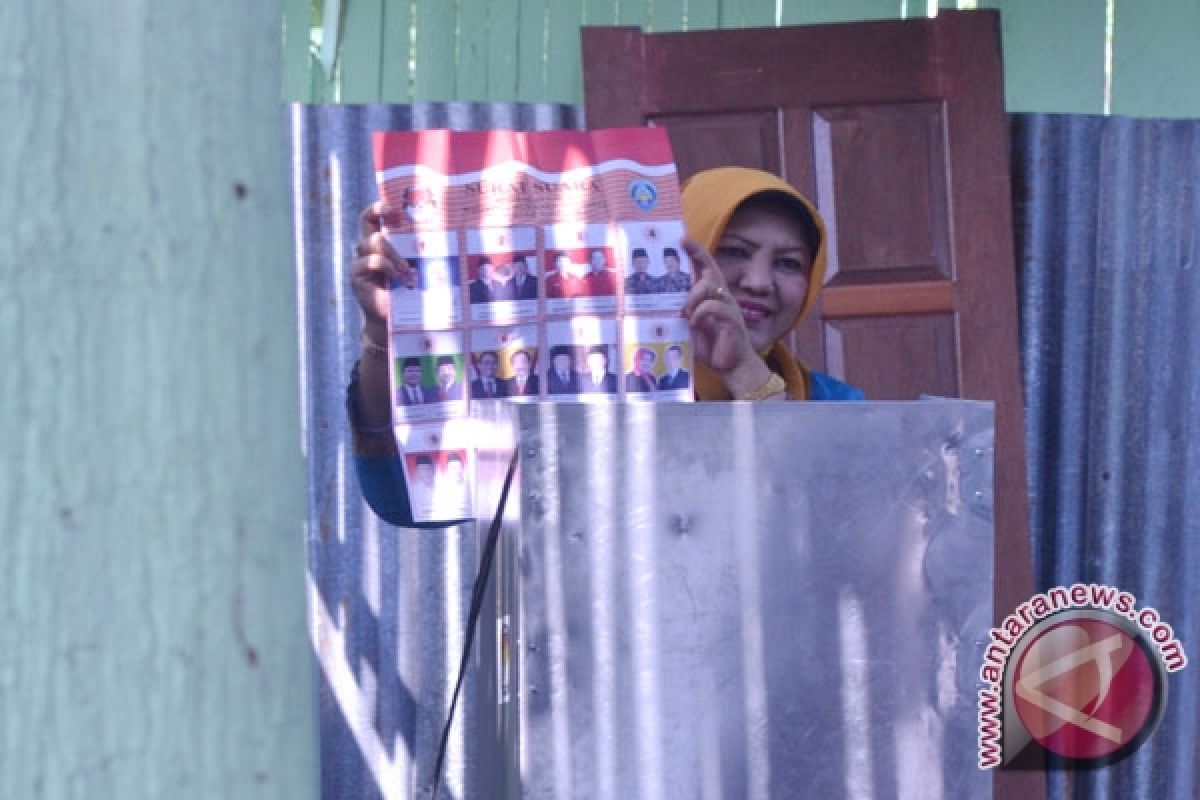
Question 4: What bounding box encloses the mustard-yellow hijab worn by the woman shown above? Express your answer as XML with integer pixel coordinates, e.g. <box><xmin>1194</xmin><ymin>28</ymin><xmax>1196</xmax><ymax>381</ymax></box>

<box><xmin>682</xmin><ymin>167</ymin><xmax>826</xmax><ymax>401</ymax></box>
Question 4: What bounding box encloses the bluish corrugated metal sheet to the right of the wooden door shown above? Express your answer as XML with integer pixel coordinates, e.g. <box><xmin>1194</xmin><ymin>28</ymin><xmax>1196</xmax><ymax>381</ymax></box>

<box><xmin>1012</xmin><ymin>115</ymin><xmax>1200</xmax><ymax>799</ymax></box>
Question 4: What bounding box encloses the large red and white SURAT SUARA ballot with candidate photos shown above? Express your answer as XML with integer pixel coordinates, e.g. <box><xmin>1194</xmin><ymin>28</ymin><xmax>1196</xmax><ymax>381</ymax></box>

<box><xmin>373</xmin><ymin>128</ymin><xmax>695</xmax><ymax>522</ymax></box>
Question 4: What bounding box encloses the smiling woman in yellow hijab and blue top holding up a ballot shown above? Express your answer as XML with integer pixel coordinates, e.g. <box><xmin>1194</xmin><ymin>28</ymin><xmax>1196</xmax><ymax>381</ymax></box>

<box><xmin>347</xmin><ymin>167</ymin><xmax>863</xmax><ymax>525</ymax></box>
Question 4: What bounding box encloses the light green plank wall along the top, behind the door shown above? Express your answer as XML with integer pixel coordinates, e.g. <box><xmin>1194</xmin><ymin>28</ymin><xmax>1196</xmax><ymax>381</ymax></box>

<box><xmin>284</xmin><ymin>0</ymin><xmax>1200</xmax><ymax>116</ymax></box>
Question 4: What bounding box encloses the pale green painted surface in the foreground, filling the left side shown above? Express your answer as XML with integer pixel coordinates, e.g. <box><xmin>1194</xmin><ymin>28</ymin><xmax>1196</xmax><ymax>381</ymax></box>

<box><xmin>0</xmin><ymin>0</ymin><xmax>317</xmax><ymax>800</ymax></box>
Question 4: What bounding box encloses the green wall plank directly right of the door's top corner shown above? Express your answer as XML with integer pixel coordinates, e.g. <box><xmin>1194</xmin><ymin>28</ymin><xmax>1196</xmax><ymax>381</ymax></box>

<box><xmin>980</xmin><ymin>0</ymin><xmax>1104</xmax><ymax>114</ymax></box>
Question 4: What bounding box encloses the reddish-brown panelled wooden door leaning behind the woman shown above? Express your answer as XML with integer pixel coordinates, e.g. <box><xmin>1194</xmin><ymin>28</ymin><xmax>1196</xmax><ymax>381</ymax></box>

<box><xmin>583</xmin><ymin>11</ymin><xmax>1043</xmax><ymax>796</ymax></box>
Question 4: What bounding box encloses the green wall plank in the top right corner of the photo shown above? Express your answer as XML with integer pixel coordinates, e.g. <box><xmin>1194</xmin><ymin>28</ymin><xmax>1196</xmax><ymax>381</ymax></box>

<box><xmin>1097</xmin><ymin>0</ymin><xmax>1200</xmax><ymax>118</ymax></box>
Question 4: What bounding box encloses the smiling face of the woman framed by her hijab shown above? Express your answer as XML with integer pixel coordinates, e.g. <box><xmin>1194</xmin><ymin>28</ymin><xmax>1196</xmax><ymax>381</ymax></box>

<box><xmin>713</xmin><ymin>198</ymin><xmax>812</xmax><ymax>351</ymax></box>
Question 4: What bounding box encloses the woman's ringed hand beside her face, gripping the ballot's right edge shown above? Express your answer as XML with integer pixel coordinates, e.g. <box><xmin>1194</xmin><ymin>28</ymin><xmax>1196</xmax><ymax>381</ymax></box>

<box><xmin>682</xmin><ymin>239</ymin><xmax>770</xmax><ymax>397</ymax></box>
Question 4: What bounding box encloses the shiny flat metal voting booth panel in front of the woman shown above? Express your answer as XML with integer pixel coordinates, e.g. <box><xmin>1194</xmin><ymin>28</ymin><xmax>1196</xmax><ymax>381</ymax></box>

<box><xmin>466</xmin><ymin>399</ymin><xmax>994</xmax><ymax>800</ymax></box>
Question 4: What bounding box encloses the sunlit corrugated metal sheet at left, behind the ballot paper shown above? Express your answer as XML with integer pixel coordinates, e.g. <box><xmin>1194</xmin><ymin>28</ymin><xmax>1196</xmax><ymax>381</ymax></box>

<box><xmin>289</xmin><ymin>103</ymin><xmax>581</xmax><ymax>800</ymax></box>
